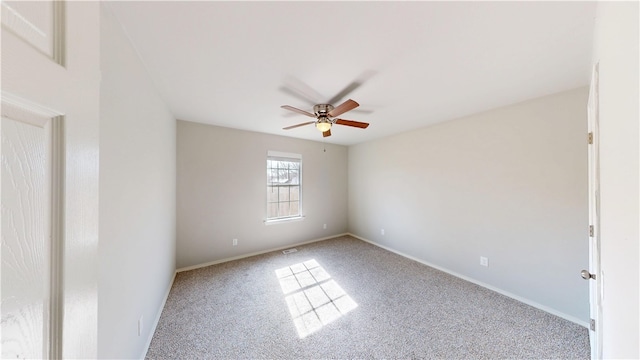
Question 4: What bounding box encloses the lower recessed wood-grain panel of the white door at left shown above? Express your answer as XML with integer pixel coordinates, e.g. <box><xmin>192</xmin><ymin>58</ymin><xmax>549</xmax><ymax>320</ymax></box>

<box><xmin>1</xmin><ymin>117</ymin><xmax>51</xmax><ymax>359</ymax></box>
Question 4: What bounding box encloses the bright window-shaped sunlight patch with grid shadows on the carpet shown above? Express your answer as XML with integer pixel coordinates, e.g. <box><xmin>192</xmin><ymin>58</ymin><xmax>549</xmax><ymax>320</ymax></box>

<box><xmin>276</xmin><ymin>259</ymin><xmax>358</xmax><ymax>339</ymax></box>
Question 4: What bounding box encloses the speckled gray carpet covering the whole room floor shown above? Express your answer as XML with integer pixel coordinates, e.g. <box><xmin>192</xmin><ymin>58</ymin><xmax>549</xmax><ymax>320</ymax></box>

<box><xmin>147</xmin><ymin>237</ymin><xmax>589</xmax><ymax>359</ymax></box>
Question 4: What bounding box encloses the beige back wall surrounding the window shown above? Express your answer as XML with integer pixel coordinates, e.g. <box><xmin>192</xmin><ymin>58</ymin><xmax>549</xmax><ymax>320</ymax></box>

<box><xmin>177</xmin><ymin>121</ymin><xmax>347</xmax><ymax>268</ymax></box>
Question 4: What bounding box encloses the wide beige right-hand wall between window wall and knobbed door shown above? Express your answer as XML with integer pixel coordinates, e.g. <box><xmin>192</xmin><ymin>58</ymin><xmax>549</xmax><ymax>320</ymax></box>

<box><xmin>349</xmin><ymin>88</ymin><xmax>589</xmax><ymax>324</ymax></box>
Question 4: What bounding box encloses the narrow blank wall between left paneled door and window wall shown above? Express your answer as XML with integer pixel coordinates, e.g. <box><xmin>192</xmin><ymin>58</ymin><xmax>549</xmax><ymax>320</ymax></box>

<box><xmin>98</xmin><ymin>4</ymin><xmax>176</xmax><ymax>359</ymax></box>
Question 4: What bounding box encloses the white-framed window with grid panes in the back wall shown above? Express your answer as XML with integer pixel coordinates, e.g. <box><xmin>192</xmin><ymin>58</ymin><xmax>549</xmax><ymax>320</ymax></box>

<box><xmin>267</xmin><ymin>151</ymin><xmax>302</xmax><ymax>221</ymax></box>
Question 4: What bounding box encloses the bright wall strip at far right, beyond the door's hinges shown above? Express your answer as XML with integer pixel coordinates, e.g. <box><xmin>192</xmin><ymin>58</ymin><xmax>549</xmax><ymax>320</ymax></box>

<box><xmin>594</xmin><ymin>2</ymin><xmax>640</xmax><ymax>359</ymax></box>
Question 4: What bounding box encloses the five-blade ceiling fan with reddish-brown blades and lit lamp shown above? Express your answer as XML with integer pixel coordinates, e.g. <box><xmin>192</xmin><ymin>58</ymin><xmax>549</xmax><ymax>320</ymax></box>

<box><xmin>280</xmin><ymin>99</ymin><xmax>369</xmax><ymax>137</ymax></box>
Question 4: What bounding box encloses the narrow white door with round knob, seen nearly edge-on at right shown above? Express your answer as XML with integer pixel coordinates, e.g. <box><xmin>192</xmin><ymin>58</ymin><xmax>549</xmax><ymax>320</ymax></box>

<box><xmin>582</xmin><ymin>64</ymin><xmax>604</xmax><ymax>359</ymax></box>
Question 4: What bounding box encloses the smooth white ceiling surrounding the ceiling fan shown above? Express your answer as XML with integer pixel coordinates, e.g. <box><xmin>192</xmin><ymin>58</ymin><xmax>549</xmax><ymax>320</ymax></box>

<box><xmin>109</xmin><ymin>1</ymin><xmax>596</xmax><ymax>145</ymax></box>
